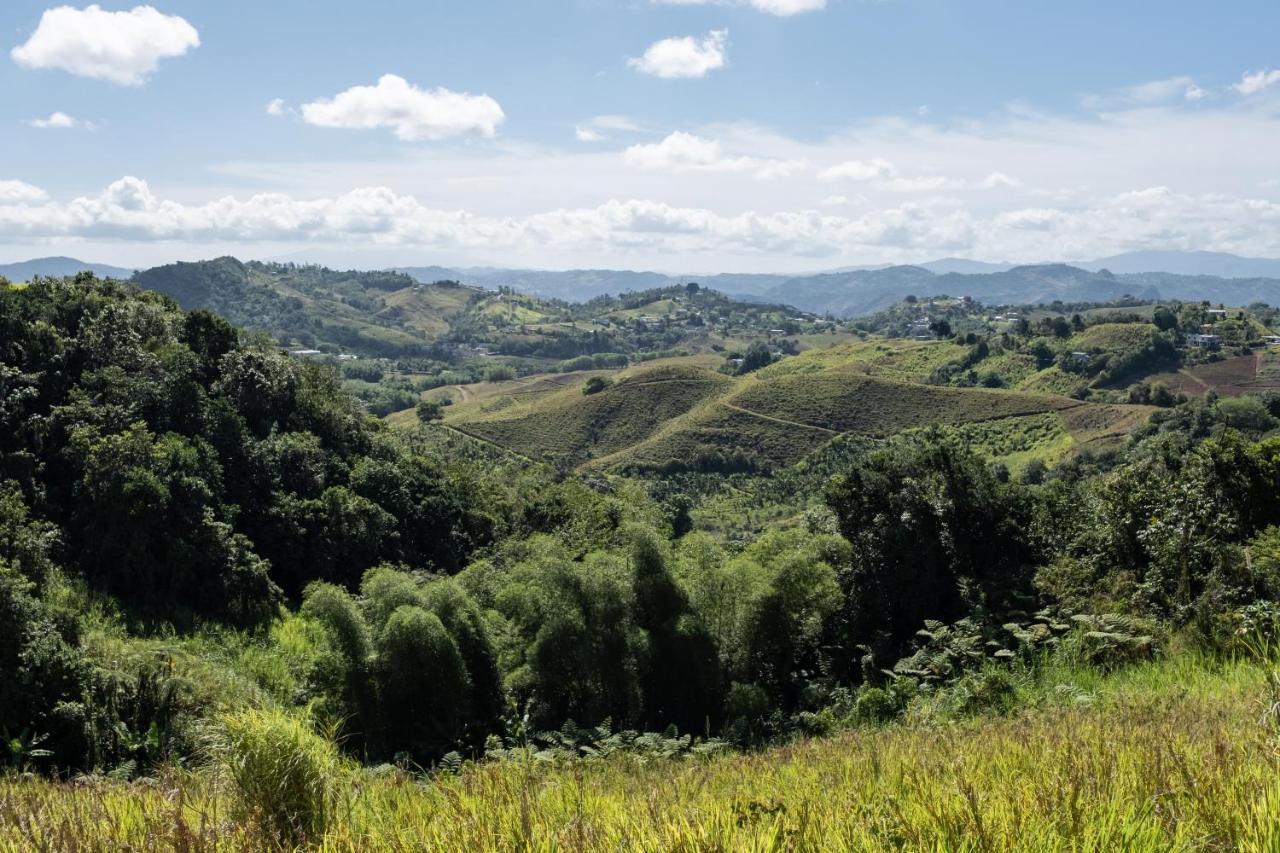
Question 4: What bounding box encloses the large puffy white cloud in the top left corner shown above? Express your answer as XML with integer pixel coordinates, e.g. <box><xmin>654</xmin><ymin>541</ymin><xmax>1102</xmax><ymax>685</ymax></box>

<box><xmin>9</xmin><ymin>4</ymin><xmax>200</xmax><ymax>86</ymax></box>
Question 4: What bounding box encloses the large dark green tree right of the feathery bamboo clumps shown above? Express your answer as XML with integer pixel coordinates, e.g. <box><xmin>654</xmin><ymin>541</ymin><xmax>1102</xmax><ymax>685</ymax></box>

<box><xmin>827</xmin><ymin>429</ymin><xmax>1033</xmax><ymax>680</ymax></box>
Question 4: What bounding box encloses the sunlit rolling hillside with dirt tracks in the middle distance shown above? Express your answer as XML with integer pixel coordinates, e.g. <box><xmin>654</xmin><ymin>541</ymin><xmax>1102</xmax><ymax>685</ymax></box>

<box><xmin>435</xmin><ymin>342</ymin><xmax>1153</xmax><ymax>474</ymax></box>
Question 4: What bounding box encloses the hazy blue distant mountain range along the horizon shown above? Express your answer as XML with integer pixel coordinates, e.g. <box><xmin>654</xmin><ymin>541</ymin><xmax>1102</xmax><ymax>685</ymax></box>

<box><xmin>0</xmin><ymin>251</ymin><xmax>1280</xmax><ymax>318</ymax></box>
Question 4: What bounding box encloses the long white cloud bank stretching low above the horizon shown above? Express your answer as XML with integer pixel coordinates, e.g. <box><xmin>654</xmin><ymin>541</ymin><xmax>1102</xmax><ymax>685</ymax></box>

<box><xmin>10</xmin><ymin>177</ymin><xmax>1280</xmax><ymax>265</ymax></box>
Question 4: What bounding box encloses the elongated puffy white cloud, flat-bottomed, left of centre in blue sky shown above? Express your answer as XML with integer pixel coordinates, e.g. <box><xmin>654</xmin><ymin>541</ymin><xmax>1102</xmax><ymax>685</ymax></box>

<box><xmin>302</xmin><ymin>74</ymin><xmax>506</xmax><ymax>142</ymax></box>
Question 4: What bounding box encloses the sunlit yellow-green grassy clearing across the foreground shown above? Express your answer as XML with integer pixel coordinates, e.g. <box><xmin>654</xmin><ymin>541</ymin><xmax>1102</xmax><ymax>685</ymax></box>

<box><xmin>0</xmin><ymin>656</ymin><xmax>1280</xmax><ymax>852</ymax></box>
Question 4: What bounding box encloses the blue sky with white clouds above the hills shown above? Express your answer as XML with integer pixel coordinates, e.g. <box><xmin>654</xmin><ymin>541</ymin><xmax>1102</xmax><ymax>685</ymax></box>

<box><xmin>0</xmin><ymin>0</ymin><xmax>1280</xmax><ymax>273</ymax></box>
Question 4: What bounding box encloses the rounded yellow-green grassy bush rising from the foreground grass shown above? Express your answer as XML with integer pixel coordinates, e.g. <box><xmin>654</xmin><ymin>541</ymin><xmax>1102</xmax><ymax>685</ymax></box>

<box><xmin>209</xmin><ymin>710</ymin><xmax>346</xmax><ymax>848</ymax></box>
